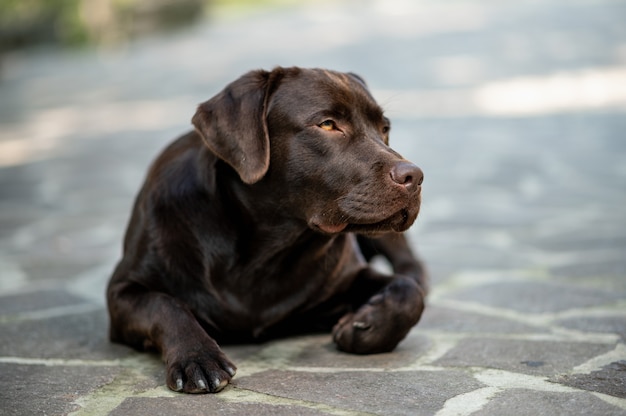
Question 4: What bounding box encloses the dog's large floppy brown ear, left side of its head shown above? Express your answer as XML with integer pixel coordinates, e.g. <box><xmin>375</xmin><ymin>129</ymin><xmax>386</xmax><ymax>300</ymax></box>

<box><xmin>191</xmin><ymin>71</ymin><xmax>277</xmax><ymax>184</ymax></box>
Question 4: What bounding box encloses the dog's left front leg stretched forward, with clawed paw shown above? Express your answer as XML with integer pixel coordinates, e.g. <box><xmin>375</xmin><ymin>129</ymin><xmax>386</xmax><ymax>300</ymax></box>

<box><xmin>108</xmin><ymin>284</ymin><xmax>236</xmax><ymax>393</ymax></box>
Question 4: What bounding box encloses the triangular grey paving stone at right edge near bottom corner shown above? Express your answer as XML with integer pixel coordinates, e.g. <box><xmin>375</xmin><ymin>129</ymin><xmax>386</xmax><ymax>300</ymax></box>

<box><xmin>551</xmin><ymin>361</ymin><xmax>626</xmax><ymax>399</ymax></box>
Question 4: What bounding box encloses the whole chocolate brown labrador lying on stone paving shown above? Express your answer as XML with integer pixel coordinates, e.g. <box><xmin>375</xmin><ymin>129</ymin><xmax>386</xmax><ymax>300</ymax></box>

<box><xmin>107</xmin><ymin>68</ymin><xmax>425</xmax><ymax>393</ymax></box>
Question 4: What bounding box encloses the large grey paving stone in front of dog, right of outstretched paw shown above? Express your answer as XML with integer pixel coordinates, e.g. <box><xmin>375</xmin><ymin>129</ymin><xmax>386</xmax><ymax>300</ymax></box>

<box><xmin>235</xmin><ymin>370</ymin><xmax>482</xmax><ymax>415</ymax></box>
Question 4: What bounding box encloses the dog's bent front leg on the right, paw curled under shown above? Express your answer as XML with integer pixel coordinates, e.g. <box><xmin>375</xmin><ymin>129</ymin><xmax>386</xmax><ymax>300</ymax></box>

<box><xmin>333</xmin><ymin>235</ymin><xmax>426</xmax><ymax>354</ymax></box>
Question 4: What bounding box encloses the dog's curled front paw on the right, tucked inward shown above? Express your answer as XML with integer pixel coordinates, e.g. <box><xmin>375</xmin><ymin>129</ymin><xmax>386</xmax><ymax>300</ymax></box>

<box><xmin>333</xmin><ymin>279</ymin><xmax>424</xmax><ymax>354</ymax></box>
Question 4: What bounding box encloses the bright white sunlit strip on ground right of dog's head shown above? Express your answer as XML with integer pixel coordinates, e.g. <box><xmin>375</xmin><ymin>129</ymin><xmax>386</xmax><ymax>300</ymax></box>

<box><xmin>374</xmin><ymin>67</ymin><xmax>626</xmax><ymax>118</ymax></box>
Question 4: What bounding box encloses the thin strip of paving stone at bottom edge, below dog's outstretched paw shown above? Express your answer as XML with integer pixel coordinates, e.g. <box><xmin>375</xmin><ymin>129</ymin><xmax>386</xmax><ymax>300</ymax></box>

<box><xmin>109</xmin><ymin>392</ymin><xmax>328</xmax><ymax>416</ymax></box>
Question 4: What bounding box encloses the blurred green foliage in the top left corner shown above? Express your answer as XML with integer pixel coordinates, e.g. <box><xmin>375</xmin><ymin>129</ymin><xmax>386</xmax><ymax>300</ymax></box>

<box><xmin>0</xmin><ymin>0</ymin><xmax>297</xmax><ymax>51</ymax></box>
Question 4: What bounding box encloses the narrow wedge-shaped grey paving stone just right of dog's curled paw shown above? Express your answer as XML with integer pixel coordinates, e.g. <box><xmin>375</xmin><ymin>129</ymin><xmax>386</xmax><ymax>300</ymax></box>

<box><xmin>418</xmin><ymin>304</ymin><xmax>548</xmax><ymax>334</ymax></box>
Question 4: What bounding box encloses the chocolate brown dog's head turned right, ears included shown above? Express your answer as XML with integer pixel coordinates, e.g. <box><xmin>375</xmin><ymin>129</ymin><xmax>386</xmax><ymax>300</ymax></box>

<box><xmin>193</xmin><ymin>68</ymin><xmax>423</xmax><ymax>234</ymax></box>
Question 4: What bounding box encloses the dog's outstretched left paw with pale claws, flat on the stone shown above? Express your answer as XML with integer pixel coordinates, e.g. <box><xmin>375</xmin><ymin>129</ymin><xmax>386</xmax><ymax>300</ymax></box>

<box><xmin>165</xmin><ymin>342</ymin><xmax>237</xmax><ymax>393</ymax></box>
